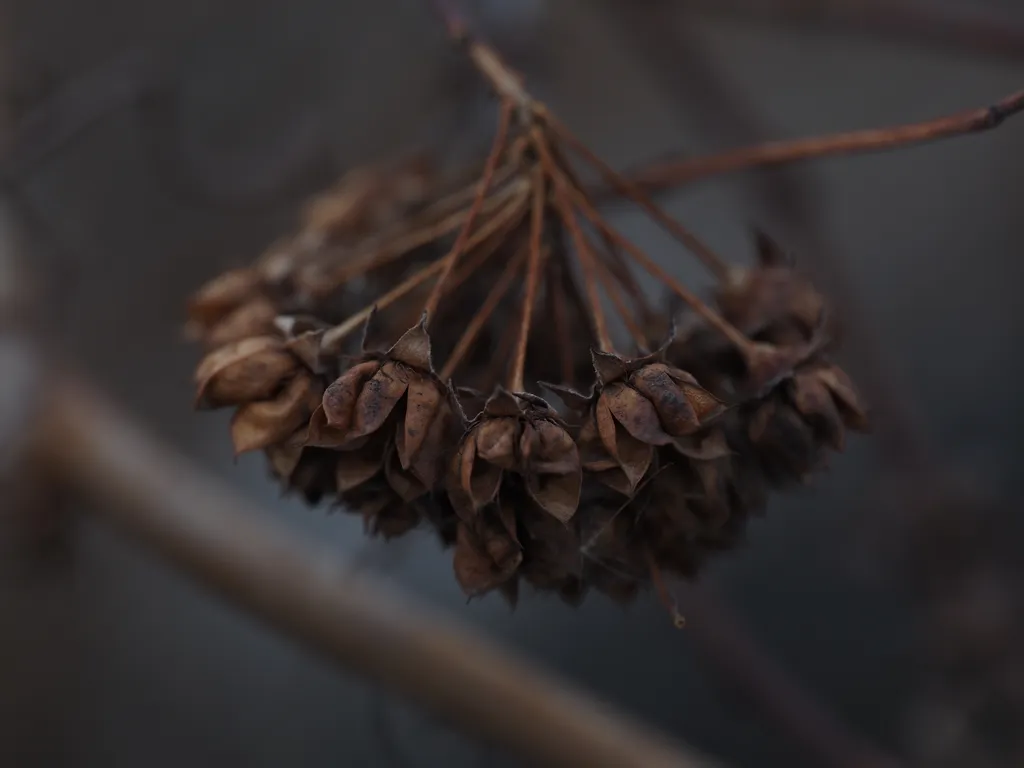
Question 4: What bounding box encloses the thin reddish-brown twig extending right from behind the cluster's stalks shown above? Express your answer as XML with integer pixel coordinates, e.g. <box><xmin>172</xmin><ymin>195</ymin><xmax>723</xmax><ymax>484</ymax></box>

<box><xmin>628</xmin><ymin>91</ymin><xmax>1024</xmax><ymax>191</ymax></box>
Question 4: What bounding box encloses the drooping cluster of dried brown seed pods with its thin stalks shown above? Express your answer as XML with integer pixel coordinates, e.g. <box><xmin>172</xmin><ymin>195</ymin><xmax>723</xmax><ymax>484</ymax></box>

<box><xmin>189</xmin><ymin>91</ymin><xmax>865</xmax><ymax>601</ymax></box>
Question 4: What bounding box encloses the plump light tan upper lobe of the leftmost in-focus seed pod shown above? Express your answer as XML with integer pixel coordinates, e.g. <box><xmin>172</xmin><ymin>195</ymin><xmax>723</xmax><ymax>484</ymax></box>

<box><xmin>196</xmin><ymin>336</ymin><xmax>297</xmax><ymax>408</ymax></box>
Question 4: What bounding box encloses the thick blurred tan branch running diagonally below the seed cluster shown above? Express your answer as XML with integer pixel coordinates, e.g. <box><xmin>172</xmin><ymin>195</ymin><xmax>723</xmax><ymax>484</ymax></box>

<box><xmin>29</xmin><ymin>376</ymin><xmax>702</xmax><ymax>768</ymax></box>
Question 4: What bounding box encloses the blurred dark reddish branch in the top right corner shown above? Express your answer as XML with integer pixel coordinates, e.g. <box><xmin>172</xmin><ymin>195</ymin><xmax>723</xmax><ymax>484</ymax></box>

<box><xmin>680</xmin><ymin>0</ymin><xmax>1024</xmax><ymax>59</ymax></box>
